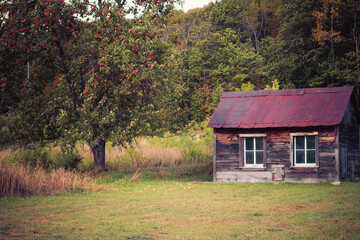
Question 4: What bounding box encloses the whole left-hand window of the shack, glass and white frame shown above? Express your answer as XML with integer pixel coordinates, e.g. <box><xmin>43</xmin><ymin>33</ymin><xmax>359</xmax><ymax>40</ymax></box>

<box><xmin>240</xmin><ymin>134</ymin><xmax>266</xmax><ymax>168</ymax></box>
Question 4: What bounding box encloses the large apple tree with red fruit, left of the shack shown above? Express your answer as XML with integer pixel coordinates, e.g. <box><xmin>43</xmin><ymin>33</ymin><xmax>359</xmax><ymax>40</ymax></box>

<box><xmin>0</xmin><ymin>0</ymin><xmax>183</xmax><ymax>169</ymax></box>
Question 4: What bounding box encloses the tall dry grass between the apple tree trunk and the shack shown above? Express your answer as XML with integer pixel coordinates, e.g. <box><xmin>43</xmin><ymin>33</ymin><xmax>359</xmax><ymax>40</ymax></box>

<box><xmin>77</xmin><ymin>136</ymin><xmax>213</xmax><ymax>171</ymax></box>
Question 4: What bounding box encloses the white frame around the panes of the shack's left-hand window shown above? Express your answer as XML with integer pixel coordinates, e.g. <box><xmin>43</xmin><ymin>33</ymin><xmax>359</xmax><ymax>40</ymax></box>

<box><xmin>240</xmin><ymin>134</ymin><xmax>266</xmax><ymax>168</ymax></box>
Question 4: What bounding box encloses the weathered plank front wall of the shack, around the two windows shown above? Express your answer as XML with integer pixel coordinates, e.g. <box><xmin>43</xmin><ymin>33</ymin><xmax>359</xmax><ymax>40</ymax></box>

<box><xmin>214</xmin><ymin>126</ymin><xmax>337</xmax><ymax>182</ymax></box>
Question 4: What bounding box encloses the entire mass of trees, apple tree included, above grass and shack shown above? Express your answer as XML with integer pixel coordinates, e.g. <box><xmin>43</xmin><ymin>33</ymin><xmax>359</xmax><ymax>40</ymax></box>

<box><xmin>0</xmin><ymin>0</ymin><xmax>360</xmax><ymax>168</ymax></box>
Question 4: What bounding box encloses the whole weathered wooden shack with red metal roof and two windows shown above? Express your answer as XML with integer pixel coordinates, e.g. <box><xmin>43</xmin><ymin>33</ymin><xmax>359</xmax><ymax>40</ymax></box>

<box><xmin>208</xmin><ymin>87</ymin><xmax>360</xmax><ymax>182</ymax></box>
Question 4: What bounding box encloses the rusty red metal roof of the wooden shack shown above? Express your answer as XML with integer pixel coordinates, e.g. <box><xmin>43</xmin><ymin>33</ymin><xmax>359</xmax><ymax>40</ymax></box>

<box><xmin>208</xmin><ymin>87</ymin><xmax>354</xmax><ymax>128</ymax></box>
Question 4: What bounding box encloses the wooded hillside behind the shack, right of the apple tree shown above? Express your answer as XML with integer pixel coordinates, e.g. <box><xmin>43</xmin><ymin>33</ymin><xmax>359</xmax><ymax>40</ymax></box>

<box><xmin>167</xmin><ymin>0</ymin><xmax>360</xmax><ymax>121</ymax></box>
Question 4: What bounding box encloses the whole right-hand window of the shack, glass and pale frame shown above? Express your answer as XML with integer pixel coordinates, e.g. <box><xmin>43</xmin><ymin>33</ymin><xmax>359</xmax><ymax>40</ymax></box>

<box><xmin>291</xmin><ymin>133</ymin><xmax>318</xmax><ymax>167</ymax></box>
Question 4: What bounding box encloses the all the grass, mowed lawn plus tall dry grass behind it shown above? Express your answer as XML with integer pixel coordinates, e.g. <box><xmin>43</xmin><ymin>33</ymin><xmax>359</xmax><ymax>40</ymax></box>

<box><xmin>0</xmin><ymin>133</ymin><xmax>360</xmax><ymax>239</ymax></box>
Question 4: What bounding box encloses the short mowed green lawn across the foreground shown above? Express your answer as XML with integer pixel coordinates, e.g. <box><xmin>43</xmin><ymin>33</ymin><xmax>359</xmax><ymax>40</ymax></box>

<box><xmin>0</xmin><ymin>177</ymin><xmax>360</xmax><ymax>239</ymax></box>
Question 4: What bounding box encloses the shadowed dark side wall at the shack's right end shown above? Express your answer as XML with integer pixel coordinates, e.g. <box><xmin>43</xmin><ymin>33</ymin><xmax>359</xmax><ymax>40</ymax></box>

<box><xmin>339</xmin><ymin>103</ymin><xmax>360</xmax><ymax>180</ymax></box>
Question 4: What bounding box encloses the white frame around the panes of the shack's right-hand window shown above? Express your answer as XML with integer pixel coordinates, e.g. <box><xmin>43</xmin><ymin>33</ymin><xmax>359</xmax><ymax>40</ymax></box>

<box><xmin>290</xmin><ymin>132</ymin><xmax>319</xmax><ymax>168</ymax></box>
